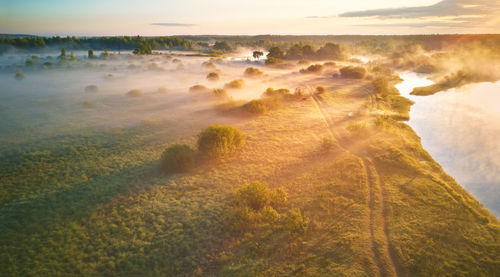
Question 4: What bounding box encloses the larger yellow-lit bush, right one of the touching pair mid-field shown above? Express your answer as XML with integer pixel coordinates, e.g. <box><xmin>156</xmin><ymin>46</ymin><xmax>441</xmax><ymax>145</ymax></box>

<box><xmin>198</xmin><ymin>125</ymin><xmax>245</xmax><ymax>159</ymax></box>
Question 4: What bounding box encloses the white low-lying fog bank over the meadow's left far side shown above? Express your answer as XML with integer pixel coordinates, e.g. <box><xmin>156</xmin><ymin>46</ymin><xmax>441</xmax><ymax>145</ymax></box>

<box><xmin>0</xmin><ymin>50</ymin><xmax>324</xmax><ymax>143</ymax></box>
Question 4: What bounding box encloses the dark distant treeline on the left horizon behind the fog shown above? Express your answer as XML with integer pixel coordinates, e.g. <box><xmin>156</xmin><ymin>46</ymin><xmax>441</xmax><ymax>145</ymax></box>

<box><xmin>0</xmin><ymin>36</ymin><xmax>195</xmax><ymax>53</ymax></box>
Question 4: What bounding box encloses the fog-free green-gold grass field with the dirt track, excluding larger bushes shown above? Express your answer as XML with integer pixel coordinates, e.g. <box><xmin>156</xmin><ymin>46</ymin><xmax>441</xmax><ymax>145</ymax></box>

<box><xmin>0</xmin><ymin>51</ymin><xmax>500</xmax><ymax>276</ymax></box>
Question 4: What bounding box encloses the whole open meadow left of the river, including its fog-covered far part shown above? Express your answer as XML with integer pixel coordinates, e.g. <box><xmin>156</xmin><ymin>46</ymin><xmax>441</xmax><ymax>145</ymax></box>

<box><xmin>0</xmin><ymin>40</ymin><xmax>500</xmax><ymax>276</ymax></box>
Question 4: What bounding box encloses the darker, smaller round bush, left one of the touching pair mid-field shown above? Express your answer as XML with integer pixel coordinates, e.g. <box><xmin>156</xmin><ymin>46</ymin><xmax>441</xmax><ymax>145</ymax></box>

<box><xmin>160</xmin><ymin>144</ymin><xmax>196</xmax><ymax>173</ymax></box>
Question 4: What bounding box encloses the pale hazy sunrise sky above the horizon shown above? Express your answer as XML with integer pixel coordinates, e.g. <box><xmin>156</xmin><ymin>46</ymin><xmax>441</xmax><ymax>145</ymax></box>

<box><xmin>0</xmin><ymin>0</ymin><xmax>500</xmax><ymax>36</ymax></box>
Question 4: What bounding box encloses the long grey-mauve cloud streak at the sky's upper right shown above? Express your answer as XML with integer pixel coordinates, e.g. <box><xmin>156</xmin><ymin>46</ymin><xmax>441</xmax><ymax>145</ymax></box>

<box><xmin>339</xmin><ymin>0</ymin><xmax>494</xmax><ymax>19</ymax></box>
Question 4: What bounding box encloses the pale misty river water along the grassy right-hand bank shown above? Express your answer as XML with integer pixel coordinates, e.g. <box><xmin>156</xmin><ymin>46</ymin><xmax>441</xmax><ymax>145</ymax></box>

<box><xmin>396</xmin><ymin>72</ymin><xmax>500</xmax><ymax>217</ymax></box>
